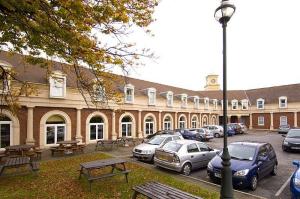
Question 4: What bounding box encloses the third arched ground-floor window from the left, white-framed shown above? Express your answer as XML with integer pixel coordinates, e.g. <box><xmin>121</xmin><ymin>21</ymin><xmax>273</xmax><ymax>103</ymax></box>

<box><xmin>89</xmin><ymin>116</ymin><xmax>104</xmax><ymax>140</ymax></box>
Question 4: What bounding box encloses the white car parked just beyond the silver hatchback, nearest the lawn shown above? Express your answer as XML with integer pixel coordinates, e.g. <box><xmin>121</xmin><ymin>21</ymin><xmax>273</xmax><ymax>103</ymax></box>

<box><xmin>132</xmin><ymin>134</ymin><xmax>183</xmax><ymax>161</ymax></box>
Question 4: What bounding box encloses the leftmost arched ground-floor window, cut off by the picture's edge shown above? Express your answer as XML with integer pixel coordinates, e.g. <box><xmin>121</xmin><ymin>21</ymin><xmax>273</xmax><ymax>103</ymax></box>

<box><xmin>0</xmin><ymin>115</ymin><xmax>12</xmax><ymax>148</ymax></box>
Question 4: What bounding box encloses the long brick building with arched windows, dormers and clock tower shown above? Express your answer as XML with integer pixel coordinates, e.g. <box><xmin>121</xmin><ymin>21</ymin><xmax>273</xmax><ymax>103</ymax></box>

<box><xmin>0</xmin><ymin>52</ymin><xmax>300</xmax><ymax>148</ymax></box>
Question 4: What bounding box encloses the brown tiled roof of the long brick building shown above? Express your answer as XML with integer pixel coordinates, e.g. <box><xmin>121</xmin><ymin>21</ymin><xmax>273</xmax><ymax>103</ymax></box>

<box><xmin>0</xmin><ymin>51</ymin><xmax>300</xmax><ymax>104</ymax></box>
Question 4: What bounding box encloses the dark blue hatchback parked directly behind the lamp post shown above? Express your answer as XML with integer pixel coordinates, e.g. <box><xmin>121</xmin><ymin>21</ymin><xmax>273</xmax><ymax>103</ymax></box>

<box><xmin>207</xmin><ymin>142</ymin><xmax>278</xmax><ymax>190</ymax></box>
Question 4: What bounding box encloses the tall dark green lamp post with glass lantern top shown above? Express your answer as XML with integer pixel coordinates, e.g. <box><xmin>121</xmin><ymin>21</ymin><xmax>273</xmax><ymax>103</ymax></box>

<box><xmin>215</xmin><ymin>0</ymin><xmax>235</xmax><ymax>199</ymax></box>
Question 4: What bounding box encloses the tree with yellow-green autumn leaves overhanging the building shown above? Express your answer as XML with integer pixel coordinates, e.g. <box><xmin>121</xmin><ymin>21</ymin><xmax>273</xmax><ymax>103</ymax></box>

<box><xmin>0</xmin><ymin>0</ymin><xmax>158</xmax><ymax>112</ymax></box>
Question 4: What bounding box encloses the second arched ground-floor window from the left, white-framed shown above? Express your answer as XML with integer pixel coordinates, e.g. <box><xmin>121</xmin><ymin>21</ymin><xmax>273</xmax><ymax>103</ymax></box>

<box><xmin>46</xmin><ymin>115</ymin><xmax>66</xmax><ymax>144</ymax></box>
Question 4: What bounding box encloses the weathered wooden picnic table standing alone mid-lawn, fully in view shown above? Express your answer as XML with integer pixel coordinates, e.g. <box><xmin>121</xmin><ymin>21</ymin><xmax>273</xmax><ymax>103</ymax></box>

<box><xmin>79</xmin><ymin>158</ymin><xmax>130</xmax><ymax>191</ymax></box>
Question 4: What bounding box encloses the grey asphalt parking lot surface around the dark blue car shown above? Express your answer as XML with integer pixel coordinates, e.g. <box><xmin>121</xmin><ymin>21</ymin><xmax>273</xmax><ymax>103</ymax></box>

<box><xmin>191</xmin><ymin>131</ymin><xmax>300</xmax><ymax>199</ymax></box>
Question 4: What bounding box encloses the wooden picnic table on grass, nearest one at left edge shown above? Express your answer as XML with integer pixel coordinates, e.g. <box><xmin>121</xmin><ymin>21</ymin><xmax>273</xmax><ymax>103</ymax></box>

<box><xmin>0</xmin><ymin>157</ymin><xmax>39</xmax><ymax>176</ymax></box>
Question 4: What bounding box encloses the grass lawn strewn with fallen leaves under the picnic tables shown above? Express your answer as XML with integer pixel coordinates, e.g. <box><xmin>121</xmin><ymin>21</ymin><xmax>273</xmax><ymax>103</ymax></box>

<box><xmin>0</xmin><ymin>153</ymin><xmax>219</xmax><ymax>199</ymax></box>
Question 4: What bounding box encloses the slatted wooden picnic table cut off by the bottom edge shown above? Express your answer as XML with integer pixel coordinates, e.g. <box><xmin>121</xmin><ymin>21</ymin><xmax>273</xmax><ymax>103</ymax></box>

<box><xmin>132</xmin><ymin>182</ymin><xmax>202</xmax><ymax>199</ymax></box>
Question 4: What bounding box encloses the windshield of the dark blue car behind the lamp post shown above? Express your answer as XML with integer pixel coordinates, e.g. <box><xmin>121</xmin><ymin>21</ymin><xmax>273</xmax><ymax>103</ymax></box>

<box><xmin>228</xmin><ymin>144</ymin><xmax>255</xmax><ymax>160</ymax></box>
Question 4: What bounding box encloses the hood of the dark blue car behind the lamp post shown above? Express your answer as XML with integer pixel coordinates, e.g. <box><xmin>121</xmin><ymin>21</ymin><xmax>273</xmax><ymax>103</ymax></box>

<box><xmin>210</xmin><ymin>155</ymin><xmax>254</xmax><ymax>171</ymax></box>
